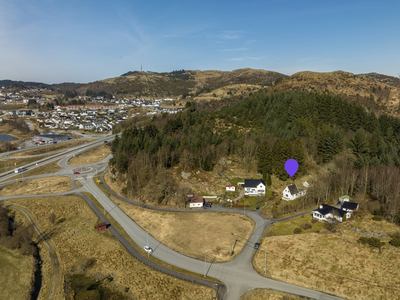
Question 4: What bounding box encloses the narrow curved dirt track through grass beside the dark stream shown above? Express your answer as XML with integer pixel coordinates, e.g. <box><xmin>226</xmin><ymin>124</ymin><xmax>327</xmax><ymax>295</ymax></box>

<box><xmin>10</xmin><ymin>205</ymin><xmax>60</xmax><ymax>300</ymax></box>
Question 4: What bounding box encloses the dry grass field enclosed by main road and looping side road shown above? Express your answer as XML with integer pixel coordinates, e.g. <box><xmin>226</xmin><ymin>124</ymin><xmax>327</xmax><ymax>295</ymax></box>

<box><xmin>113</xmin><ymin>199</ymin><xmax>254</xmax><ymax>262</ymax></box>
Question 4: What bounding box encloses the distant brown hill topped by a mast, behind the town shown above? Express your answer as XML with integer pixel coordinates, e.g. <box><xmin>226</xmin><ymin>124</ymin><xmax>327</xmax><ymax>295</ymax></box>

<box><xmin>73</xmin><ymin>69</ymin><xmax>286</xmax><ymax>97</ymax></box>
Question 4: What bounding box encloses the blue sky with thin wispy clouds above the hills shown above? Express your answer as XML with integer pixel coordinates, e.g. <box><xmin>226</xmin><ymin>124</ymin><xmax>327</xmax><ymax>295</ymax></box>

<box><xmin>0</xmin><ymin>0</ymin><xmax>400</xmax><ymax>83</ymax></box>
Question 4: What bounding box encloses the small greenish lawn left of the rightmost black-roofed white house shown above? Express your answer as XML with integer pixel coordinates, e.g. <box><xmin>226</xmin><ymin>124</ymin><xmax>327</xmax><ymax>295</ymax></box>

<box><xmin>267</xmin><ymin>213</ymin><xmax>325</xmax><ymax>236</ymax></box>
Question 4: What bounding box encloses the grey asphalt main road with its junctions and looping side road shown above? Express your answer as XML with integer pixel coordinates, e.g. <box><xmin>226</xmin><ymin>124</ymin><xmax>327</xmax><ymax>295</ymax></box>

<box><xmin>0</xmin><ymin>136</ymin><xmax>342</xmax><ymax>300</ymax></box>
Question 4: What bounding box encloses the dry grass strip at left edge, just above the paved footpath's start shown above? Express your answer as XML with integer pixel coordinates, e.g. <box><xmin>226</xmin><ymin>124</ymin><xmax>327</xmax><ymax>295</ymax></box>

<box><xmin>0</xmin><ymin>176</ymin><xmax>73</xmax><ymax>196</ymax></box>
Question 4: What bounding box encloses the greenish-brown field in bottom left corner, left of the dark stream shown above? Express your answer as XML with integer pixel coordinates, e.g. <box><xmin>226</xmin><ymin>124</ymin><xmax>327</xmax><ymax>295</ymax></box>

<box><xmin>0</xmin><ymin>247</ymin><xmax>33</xmax><ymax>299</ymax></box>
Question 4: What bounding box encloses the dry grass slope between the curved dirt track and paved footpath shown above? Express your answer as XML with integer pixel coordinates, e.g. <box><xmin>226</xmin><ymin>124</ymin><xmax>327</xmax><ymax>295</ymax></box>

<box><xmin>7</xmin><ymin>197</ymin><xmax>211</xmax><ymax>300</ymax></box>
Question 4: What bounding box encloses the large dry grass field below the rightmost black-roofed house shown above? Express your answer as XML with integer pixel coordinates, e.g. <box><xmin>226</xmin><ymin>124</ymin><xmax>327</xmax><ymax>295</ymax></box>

<box><xmin>253</xmin><ymin>215</ymin><xmax>400</xmax><ymax>299</ymax></box>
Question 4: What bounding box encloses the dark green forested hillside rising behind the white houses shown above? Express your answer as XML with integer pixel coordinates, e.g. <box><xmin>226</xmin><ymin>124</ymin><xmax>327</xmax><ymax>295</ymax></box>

<box><xmin>112</xmin><ymin>92</ymin><xmax>400</xmax><ymax>221</ymax></box>
